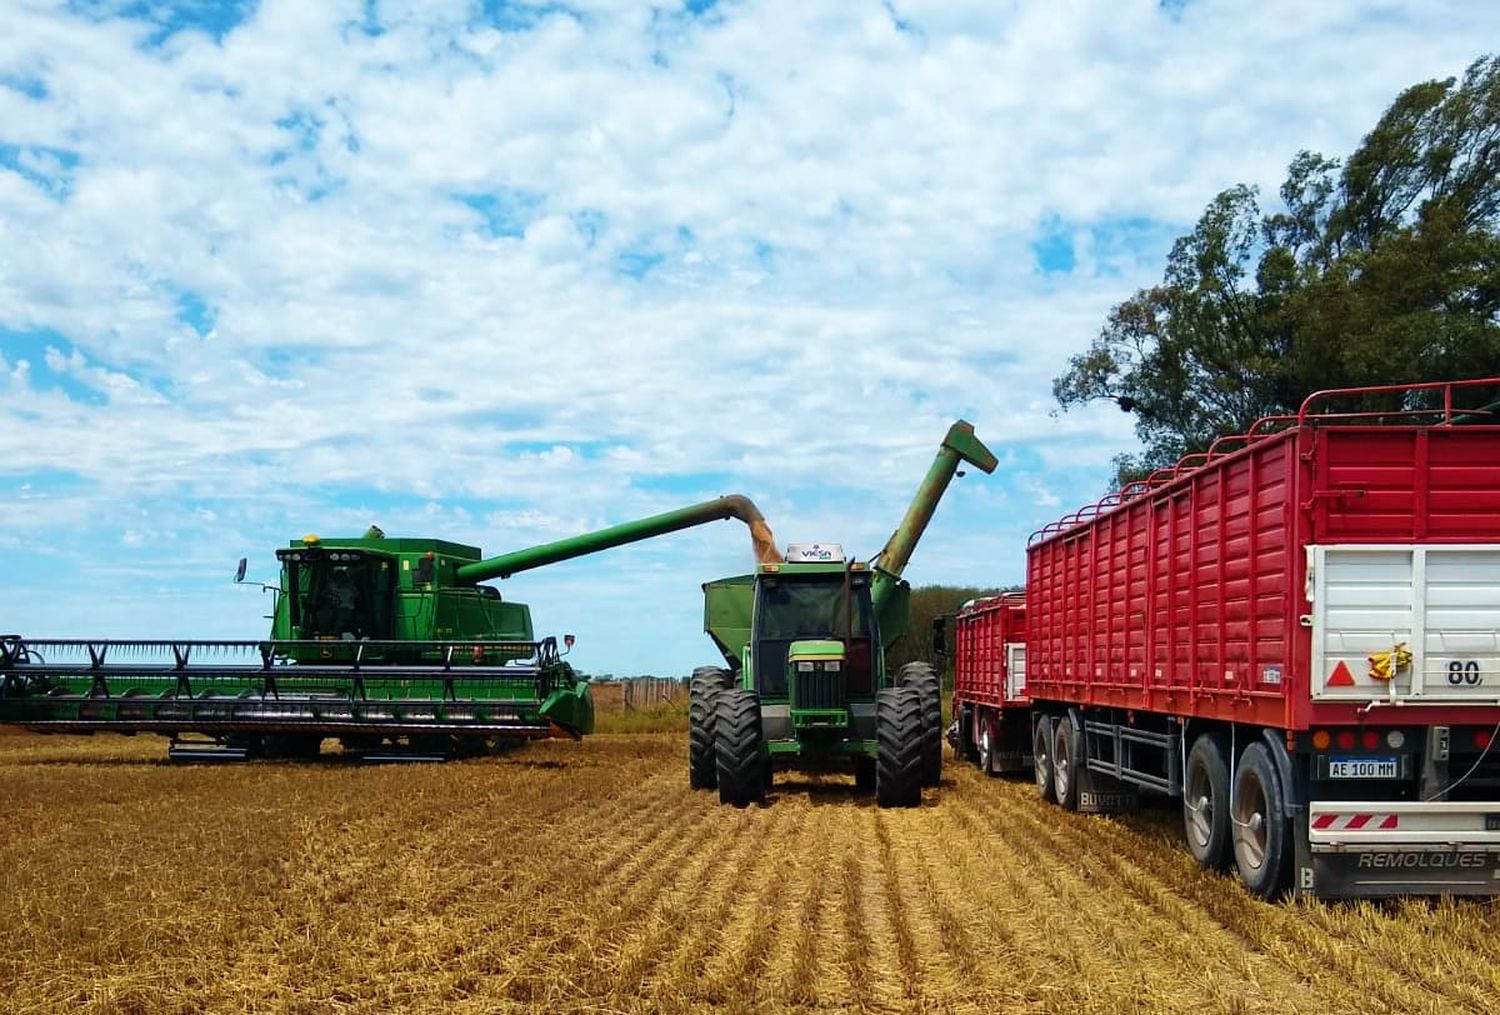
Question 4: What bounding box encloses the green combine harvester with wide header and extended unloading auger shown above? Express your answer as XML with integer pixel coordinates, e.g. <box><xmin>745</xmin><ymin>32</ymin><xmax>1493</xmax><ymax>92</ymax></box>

<box><xmin>0</xmin><ymin>496</ymin><xmax>782</xmax><ymax>760</ymax></box>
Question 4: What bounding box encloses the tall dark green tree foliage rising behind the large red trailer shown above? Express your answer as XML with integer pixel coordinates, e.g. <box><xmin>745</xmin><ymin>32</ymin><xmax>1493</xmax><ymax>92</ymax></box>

<box><xmin>1053</xmin><ymin>55</ymin><xmax>1500</xmax><ymax>480</ymax></box>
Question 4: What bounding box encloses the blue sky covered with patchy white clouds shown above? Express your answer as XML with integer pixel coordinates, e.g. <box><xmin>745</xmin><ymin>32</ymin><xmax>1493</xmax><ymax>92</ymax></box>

<box><xmin>0</xmin><ymin>0</ymin><xmax>1500</xmax><ymax>675</ymax></box>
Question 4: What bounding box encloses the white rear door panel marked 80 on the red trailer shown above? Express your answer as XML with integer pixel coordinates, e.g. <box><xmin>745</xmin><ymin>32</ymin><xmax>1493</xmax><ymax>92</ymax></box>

<box><xmin>1304</xmin><ymin>544</ymin><xmax>1500</xmax><ymax>703</ymax></box>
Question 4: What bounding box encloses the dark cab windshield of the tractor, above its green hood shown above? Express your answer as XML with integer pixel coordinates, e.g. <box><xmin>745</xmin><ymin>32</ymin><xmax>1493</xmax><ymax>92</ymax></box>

<box><xmin>755</xmin><ymin>571</ymin><xmax>872</xmax><ymax>697</ymax></box>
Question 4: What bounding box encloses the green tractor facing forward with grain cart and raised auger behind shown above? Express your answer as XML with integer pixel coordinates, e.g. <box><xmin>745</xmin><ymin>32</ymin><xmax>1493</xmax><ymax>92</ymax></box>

<box><xmin>689</xmin><ymin>420</ymin><xmax>995</xmax><ymax>807</ymax></box>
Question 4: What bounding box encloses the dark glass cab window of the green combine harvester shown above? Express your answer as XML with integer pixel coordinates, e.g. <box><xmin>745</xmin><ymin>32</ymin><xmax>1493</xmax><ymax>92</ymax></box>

<box><xmin>279</xmin><ymin>550</ymin><xmax>392</xmax><ymax>640</ymax></box>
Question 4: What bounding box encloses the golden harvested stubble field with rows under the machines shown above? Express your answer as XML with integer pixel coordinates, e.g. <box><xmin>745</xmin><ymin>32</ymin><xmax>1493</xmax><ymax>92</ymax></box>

<box><xmin>0</xmin><ymin>732</ymin><xmax>1500</xmax><ymax>1015</ymax></box>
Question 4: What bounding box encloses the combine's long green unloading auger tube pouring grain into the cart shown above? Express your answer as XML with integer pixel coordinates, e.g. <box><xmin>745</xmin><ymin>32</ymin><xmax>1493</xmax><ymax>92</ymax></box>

<box><xmin>455</xmin><ymin>493</ymin><xmax>782</xmax><ymax>583</ymax></box>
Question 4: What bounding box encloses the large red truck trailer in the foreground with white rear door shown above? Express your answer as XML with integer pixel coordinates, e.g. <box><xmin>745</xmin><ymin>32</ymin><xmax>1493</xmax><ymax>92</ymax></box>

<box><xmin>1026</xmin><ymin>379</ymin><xmax>1500</xmax><ymax>898</ymax></box>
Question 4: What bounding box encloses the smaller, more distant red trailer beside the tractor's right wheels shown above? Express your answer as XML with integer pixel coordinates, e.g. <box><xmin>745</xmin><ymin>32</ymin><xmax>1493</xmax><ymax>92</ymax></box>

<box><xmin>953</xmin><ymin>592</ymin><xmax>1031</xmax><ymax>775</ymax></box>
